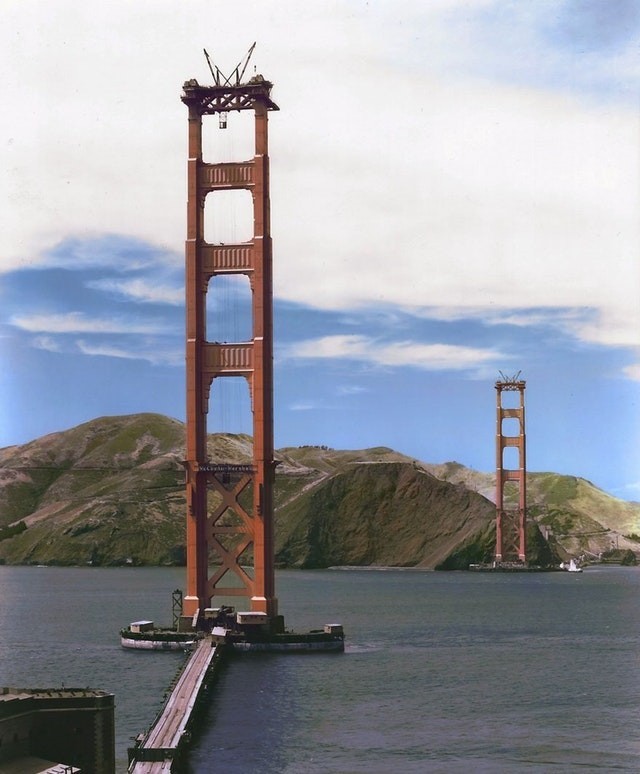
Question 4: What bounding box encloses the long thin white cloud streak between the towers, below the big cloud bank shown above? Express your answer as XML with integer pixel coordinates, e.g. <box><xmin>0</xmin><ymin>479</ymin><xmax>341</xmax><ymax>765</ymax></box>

<box><xmin>284</xmin><ymin>335</ymin><xmax>510</xmax><ymax>371</ymax></box>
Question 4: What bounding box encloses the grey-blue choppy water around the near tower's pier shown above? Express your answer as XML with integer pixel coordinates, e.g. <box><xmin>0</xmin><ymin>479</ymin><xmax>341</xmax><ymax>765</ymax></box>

<box><xmin>0</xmin><ymin>566</ymin><xmax>640</xmax><ymax>774</ymax></box>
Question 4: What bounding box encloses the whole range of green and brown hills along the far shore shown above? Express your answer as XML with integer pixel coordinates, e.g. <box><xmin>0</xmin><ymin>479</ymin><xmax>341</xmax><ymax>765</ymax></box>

<box><xmin>0</xmin><ymin>414</ymin><xmax>640</xmax><ymax>568</ymax></box>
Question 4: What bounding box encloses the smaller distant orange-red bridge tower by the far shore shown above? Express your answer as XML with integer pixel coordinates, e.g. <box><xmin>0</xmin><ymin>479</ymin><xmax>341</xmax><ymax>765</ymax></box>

<box><xmin>495</xmin><ymin>372</ymin><xmax>527</xmax><ymax>563</ymax></box>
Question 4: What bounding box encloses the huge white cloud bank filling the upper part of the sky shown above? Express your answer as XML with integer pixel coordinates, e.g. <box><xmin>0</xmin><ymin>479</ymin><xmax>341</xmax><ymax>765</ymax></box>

<box><xmin>0</xmin><ymin>0</ymin><xmax>640</xmax><ymax>354</ymax></box>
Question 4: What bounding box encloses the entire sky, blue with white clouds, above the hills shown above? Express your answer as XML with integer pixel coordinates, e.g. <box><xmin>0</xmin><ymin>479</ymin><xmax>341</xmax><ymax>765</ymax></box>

<box><xmin>0</xmin><ymin>0</ymin><xmax>640</xmax><ymax>500</ymax></box>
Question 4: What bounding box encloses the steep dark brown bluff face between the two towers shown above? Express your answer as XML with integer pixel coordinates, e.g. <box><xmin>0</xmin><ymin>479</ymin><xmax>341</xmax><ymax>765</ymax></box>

<box><xmin>277</xmin><ymin>463</ymin><xmax>495</xmax><ymax>568</ymax></box>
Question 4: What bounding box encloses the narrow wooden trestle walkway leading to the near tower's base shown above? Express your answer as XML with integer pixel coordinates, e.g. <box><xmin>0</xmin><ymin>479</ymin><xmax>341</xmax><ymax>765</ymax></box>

<box><xmin>129</xmin><ymin>637</ymin><xmax>222</xmax><ymax>774</ymax></box>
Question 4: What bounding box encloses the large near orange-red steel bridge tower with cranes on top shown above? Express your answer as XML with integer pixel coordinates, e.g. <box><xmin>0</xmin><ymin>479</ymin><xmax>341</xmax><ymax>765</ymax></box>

<box><xmin>181</xmin><ymin>51</ymin><xmax>278</xmax><ymax>619</ymax></box>
